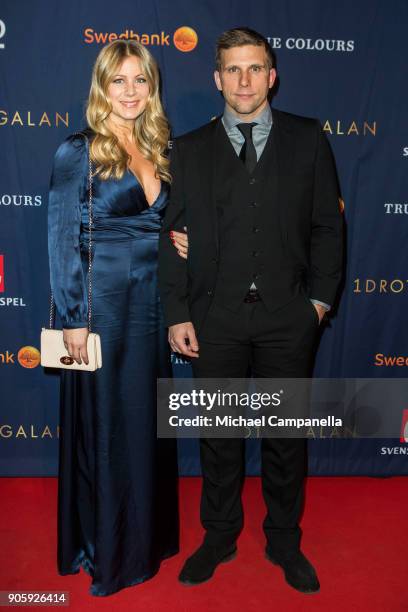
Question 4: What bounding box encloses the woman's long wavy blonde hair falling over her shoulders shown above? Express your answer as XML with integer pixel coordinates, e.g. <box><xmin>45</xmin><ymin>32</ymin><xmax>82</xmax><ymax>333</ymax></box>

<box><xmin>86</xmin><ymin>40</ymin><xmax>171</xmax><ymax>183</ymax></box>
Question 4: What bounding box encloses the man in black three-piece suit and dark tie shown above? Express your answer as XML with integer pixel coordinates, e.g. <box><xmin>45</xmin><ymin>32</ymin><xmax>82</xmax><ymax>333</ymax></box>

<box><xmin>159</xmin><ymin>28</ymin><xmax>342</xmax><ymax>592</ymax></box>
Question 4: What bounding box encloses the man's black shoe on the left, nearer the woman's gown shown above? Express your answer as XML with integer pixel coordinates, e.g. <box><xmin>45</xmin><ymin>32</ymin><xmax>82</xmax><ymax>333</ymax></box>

<box><xmin>179</xmin><ymin>543</ymin><xmax>237</xmax><ymax>586</ymax></box>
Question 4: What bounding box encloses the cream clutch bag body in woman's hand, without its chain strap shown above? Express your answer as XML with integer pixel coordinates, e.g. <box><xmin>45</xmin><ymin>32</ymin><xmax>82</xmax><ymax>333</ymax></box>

<box><xmin>41</xmin><ymin>327</ymin><xmax>102</xmax><ymax>372</ymax></box>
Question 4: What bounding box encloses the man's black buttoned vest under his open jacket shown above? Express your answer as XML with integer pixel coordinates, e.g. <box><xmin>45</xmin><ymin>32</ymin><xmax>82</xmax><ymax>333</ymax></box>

<box><xmin>214</xmin><ymin>125</ymin><xmax>299</xmax><ymax>311</ymax></box>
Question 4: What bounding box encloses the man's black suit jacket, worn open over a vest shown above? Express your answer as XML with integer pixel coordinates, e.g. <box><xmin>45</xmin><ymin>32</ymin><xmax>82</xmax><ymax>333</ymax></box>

<box><xmin>158</xmin><ymin>109</ymin><xmax>342</xmax><ymax>331</ymax></box>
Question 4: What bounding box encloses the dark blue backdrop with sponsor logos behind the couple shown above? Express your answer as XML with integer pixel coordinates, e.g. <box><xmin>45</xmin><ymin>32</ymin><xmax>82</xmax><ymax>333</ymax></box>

<box><xmin>0</xmin><ymin>0</ymin><xmax>408</xmax><ymax>475</ymax></box>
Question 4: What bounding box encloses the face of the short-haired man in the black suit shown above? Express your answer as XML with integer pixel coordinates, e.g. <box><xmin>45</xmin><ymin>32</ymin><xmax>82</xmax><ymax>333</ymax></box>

<box><xmin>214</xmin><ymin>45</ymin><xmax>276</xmax><ymax>121</ymax></box>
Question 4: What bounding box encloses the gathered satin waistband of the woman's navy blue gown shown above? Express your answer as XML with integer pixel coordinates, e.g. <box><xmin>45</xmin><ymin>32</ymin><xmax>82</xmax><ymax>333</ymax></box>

<box><xmin>81</xmin><ymin>215</ymin><xmax>161</xmax><ymax>242</ymax></box>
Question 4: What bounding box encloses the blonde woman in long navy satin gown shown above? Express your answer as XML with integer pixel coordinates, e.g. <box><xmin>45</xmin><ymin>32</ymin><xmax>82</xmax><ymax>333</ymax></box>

<box><xmin>49</xmin><ymin>41</ymin><xmax>186</xmax><ymax>595</ymax></box>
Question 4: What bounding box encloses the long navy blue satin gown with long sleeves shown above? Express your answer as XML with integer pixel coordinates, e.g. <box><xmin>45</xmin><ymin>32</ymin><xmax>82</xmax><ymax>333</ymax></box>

<box><xmin>49</xmin><ymin>135</ymin><xmax>178</xmax><ymax>595</ymax></box>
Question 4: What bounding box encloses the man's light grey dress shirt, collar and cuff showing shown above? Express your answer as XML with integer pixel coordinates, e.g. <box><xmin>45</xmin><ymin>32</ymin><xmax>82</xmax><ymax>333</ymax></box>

<box><xmin>221</xmin><ymin>104</ymin><xmax>330</xmax><ymax>310</ymax></box>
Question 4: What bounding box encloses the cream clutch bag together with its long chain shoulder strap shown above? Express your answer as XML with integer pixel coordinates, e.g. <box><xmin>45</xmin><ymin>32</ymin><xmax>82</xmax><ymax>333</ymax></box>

<box><xmin>41</xmin><ymin>134</ymin><xmax>102</xmax><ymax>372</ymax></box>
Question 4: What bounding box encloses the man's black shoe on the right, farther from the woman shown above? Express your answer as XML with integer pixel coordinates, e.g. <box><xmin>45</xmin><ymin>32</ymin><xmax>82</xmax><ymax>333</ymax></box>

<box><xmin>265</xmin><ymin>546</ymin><xmax>320</xmax><ymax>593</ymax></box>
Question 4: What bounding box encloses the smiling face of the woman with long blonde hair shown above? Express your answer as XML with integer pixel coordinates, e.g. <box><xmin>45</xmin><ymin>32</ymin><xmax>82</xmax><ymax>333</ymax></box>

<box><xmin>107</xmin><ymin>55</ymin><xmax>149</xmax><ymax>123</ymax></box>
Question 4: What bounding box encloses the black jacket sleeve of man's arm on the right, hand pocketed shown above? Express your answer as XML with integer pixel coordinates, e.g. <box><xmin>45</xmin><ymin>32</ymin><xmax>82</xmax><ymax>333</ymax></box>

<box><xmin>310</xmin><ymin>122</ymin><xmax>343</xmax><ymax>305</ymax></box>
